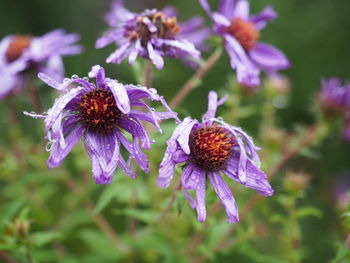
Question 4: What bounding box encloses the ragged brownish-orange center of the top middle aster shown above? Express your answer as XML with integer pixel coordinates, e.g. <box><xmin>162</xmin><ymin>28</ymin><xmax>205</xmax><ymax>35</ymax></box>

<box><xmin>130</xmin><ymin>12</ymin><xmax>180</xmax><ymax>45</ymax></box>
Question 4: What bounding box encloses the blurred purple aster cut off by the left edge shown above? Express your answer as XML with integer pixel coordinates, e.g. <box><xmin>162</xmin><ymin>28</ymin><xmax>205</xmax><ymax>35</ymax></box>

<box><xmin>0</xmin><ymin>29</ymin><xmax>81</xmax><ymax>99</ymax></box>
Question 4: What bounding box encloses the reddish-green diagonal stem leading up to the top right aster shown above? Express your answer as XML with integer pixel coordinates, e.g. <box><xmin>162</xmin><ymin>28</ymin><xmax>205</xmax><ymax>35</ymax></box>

<box><xmin>170</xmin><ymin>48</ymin><xmax>222</xmax><ymax>108</ymax></box>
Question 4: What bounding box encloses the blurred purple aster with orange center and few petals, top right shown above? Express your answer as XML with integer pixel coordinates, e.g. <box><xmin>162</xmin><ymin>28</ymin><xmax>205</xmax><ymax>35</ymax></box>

<box><xmin>199</xmin><ymin>0</ymin><xmax>290</xmax><ymax>87</ymax></box>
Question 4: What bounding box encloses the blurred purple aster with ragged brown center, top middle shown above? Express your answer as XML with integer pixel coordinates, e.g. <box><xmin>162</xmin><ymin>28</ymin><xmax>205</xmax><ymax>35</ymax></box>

<box><xmin>96</xmin><ymin>1</ymin><xmax>210</xmax><ymax>69</ymax></box>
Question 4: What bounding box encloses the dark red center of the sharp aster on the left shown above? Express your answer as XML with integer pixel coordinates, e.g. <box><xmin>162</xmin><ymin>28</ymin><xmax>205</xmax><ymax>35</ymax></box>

<box><xmin>79</xmin><ymin>89</ymin><xmax>122</xmax><ymax>133</ymax></box>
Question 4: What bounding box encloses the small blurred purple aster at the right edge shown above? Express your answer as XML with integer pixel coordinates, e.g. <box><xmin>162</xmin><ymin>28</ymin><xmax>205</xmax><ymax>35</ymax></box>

<box><xmin>318</xmin><ymin>78</ymin><xmax>350</xmax><ymax>115</ymax></box>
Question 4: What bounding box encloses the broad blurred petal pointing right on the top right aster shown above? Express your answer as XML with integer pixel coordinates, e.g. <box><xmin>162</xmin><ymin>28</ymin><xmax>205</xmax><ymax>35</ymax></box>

<box><xmin>249</xmin><ymin>43</ymin><xmax>290</xmax><ymax>70</ymax></box>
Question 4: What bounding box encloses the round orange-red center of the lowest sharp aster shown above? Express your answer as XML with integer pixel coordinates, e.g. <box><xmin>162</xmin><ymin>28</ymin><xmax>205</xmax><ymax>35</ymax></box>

<box><xmin>189</xmin><ymin>125</ymin><xmax>236</xmax><ymax>171</ymax></box>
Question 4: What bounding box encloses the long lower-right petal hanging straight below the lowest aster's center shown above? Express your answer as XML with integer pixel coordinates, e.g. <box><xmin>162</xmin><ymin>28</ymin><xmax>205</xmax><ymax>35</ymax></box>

<box><xmin>209</xmin><ymin>173</ymin><xmax>239</xmax><ymax>223</ymax></box>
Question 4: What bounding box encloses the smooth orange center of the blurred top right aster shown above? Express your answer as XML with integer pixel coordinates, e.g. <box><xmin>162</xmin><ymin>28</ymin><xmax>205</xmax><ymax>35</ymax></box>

<box><xmin>227</xmin><ymin>18</ymin><xmax>260</xmax><ymax>51</ymax></box>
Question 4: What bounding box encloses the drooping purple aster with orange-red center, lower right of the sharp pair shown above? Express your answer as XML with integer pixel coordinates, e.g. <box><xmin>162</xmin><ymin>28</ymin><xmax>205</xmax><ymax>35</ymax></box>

<box><xmin>158</xmin><ymin>91</ymin><xmax>273</xmax><ymax>222</ymax></box>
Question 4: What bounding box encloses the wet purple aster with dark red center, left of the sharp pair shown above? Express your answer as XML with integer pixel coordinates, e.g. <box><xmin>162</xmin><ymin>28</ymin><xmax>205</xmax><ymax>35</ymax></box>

<box><xmin>26</xmin><ymin>66</ymin><xmax>177</xmax><ymax>184</ymax></box>
